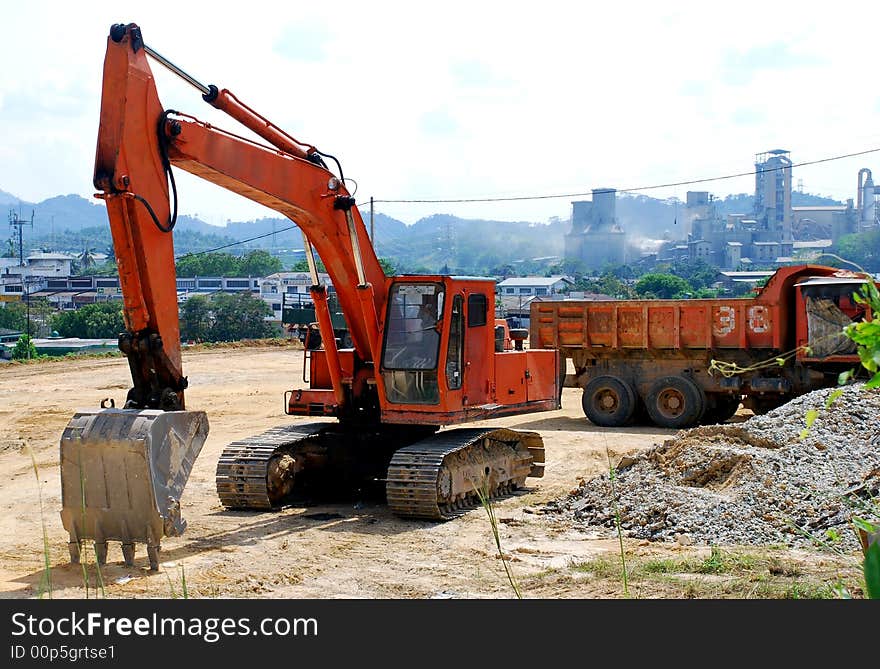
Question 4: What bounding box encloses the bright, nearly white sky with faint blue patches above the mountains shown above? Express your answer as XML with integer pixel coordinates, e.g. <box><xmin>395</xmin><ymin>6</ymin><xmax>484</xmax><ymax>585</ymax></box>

<box><xmin>0</xmin><ymin>0</ymin><xmax>880</xmax><ymax>225</ymax></box>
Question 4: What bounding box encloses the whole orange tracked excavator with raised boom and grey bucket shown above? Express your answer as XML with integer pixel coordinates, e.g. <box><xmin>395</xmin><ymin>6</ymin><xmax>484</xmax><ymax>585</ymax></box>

<box><xmin>61</xmin><ymin>24</ymin><xmax>560</xmax><ymax>569</ymax></box>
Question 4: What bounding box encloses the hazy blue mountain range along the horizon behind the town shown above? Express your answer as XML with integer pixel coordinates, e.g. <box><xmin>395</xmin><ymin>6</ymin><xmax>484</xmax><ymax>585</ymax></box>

<box><xmin>0</xmin><ymin>190</ymin><xmax>841</xmax><ymax>274</ymax></box>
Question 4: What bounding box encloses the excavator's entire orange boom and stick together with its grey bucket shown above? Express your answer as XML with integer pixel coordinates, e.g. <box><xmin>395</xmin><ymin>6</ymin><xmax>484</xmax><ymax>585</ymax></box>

<box><xmin>61</xmin><ymin>24</ymin><xmax>386</xmax><ymax>568</ymax></box>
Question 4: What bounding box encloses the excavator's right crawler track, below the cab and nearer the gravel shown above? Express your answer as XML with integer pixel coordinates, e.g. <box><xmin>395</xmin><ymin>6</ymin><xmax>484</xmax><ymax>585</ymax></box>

<box><xmin>385</xmin><ymin>428</ymin><xmax>544</xmax><ymax>520</ymax></box>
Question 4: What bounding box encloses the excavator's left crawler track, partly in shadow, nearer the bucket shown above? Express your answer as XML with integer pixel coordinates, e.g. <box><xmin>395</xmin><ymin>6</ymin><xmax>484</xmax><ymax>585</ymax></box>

<box><xmin>216</xmin><ymin>423</ymin><xmax>335</xmax><ymax>510</ymax></box>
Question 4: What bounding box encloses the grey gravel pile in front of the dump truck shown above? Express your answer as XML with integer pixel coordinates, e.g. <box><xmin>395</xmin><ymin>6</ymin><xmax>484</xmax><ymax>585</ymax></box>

<box><xmin>544</xmin><ymin>386</ymin><xmax>880</xmax><ymax>550</ymax></box>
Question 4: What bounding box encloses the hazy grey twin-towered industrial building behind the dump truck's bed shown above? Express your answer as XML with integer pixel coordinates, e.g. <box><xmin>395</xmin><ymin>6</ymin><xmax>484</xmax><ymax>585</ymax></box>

<box><xmin>565</xmin><ymin>188</ymin><xmax>626</xmax><ymax>271</ymax></box>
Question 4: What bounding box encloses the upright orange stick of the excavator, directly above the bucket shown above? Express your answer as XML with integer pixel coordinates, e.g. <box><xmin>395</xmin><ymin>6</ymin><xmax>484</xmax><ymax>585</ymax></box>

<box><xmin>94</xmin><ymin>26</ymin><xmax>187</xmax><ymax>410</ymax></box>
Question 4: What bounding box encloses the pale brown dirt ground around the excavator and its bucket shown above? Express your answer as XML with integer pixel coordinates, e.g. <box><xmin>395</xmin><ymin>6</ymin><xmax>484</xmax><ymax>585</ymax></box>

<box><xmin>0</xmin><ymin>348</ymin><xmax>858</xmax><ymax>599</ymax></box>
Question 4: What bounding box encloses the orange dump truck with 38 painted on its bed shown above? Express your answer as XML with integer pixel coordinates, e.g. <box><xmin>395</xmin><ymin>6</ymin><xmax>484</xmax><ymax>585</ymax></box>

<box><xmin>529</xmin><ymin>265</ymin><xmax>870</xmax><ymax>428</ymax></box>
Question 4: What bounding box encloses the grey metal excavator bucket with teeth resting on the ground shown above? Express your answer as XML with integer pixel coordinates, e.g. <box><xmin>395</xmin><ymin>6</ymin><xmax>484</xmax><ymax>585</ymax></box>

<box><xmin>61</xmin><ymin>409</ymin><xmax>208</xmax><ymax>569</ymax></box>
